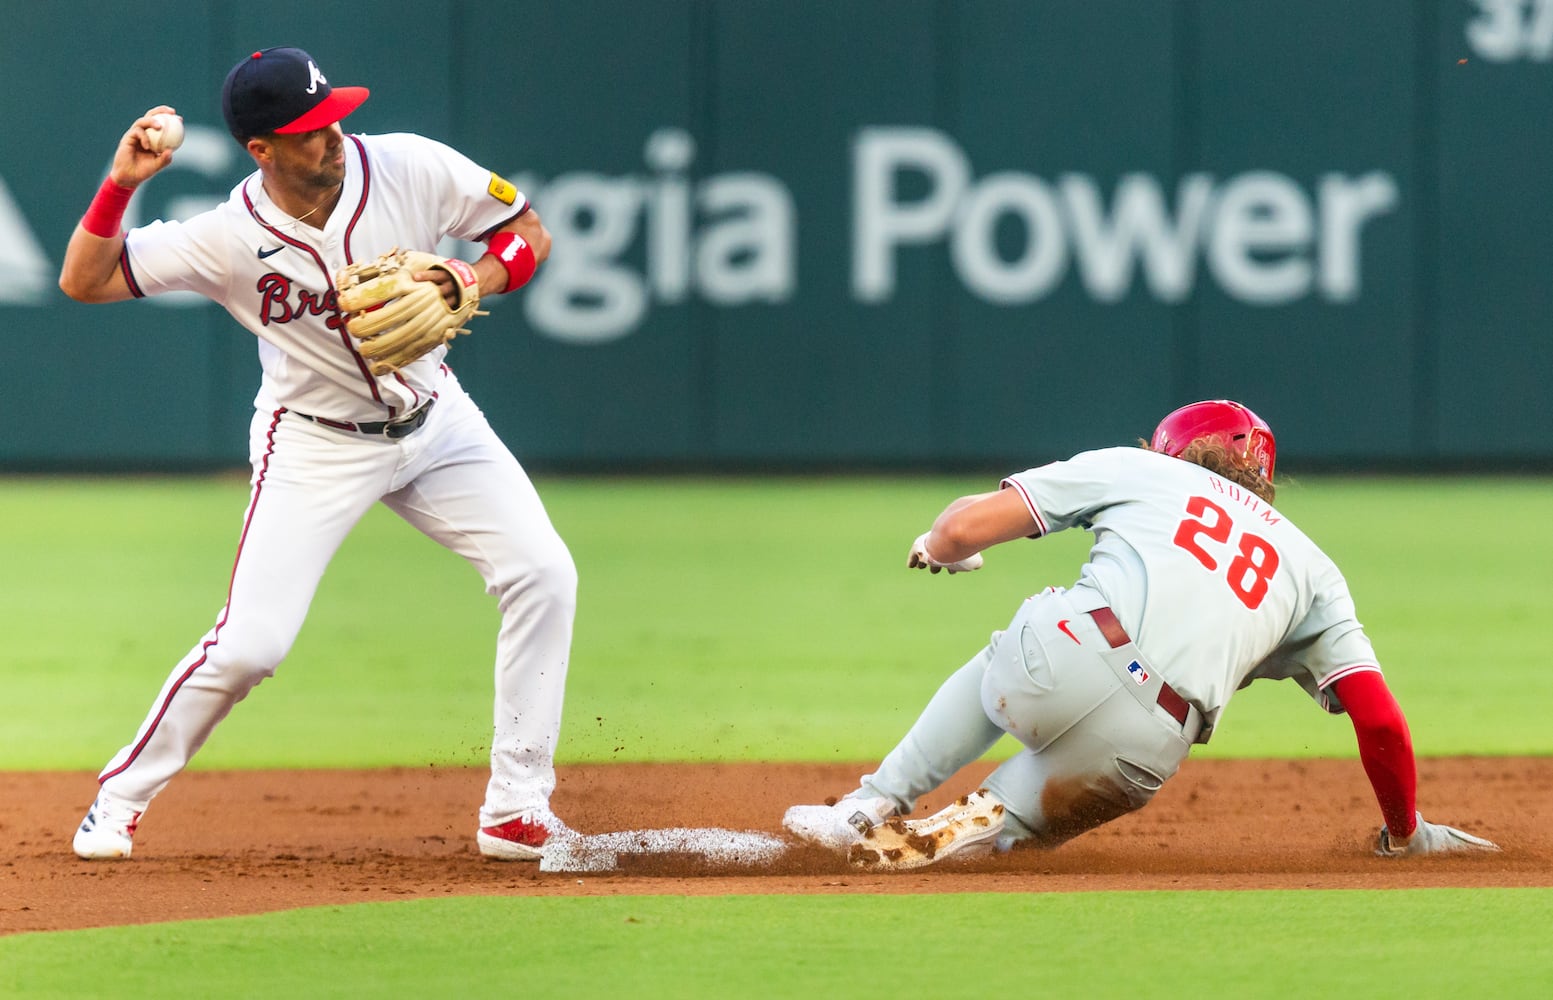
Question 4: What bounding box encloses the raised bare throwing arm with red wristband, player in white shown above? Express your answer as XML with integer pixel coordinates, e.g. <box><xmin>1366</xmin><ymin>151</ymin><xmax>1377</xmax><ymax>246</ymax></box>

<box><xmin>59</xmin><ymin>104</ymin><xmax>172</xmax><ymax>303</ymax></box>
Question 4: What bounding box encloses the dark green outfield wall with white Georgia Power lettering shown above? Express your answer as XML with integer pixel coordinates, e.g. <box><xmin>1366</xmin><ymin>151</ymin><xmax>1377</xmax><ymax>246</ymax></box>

<box><xmin>0</xmin><ymin>0</ymin><xmax>1553</xmax><ymax>469</ymax></box>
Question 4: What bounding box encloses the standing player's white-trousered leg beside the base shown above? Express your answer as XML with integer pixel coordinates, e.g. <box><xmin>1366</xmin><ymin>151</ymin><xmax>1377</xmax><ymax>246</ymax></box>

<box><xmin>384</xmin><ymin>384</ymin><xmax>576</xmax><ymax>859</ymax></box>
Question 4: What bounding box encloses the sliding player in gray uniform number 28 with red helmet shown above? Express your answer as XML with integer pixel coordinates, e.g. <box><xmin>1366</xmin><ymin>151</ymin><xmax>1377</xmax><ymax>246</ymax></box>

<box><xmin>783</xmin><ymin>399</ymin><xmax>1497</xmax><ymax>870</ymax></box>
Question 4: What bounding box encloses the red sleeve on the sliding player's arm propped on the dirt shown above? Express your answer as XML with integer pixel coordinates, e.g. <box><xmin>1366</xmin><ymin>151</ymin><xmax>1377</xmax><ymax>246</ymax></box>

<box><xmin>1332</xmin><ymin>671</ymin><xmax>1418</xmax><ymax>837</ymax></box>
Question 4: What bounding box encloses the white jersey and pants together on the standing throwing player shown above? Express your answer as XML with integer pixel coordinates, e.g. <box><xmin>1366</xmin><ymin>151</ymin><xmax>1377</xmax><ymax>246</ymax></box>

<box><xmin>90</xmin><ymin>135</ymin><xmax>576</xmax><ymax>829</ymax></box>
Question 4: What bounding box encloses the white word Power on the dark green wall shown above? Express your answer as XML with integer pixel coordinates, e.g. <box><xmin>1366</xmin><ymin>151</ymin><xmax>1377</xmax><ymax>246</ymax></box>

<box><xmin>853</xmin><ymin>127</ymin><xmax>1399</xmax><ymax>306</ymax></box>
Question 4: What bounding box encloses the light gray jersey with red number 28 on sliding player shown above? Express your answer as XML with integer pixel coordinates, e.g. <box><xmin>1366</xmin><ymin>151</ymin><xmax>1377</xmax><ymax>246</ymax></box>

<box><xmin>1003</xmin><ymin>447</ymin><xmax>1379</xmax><ymax>727</ymax></box>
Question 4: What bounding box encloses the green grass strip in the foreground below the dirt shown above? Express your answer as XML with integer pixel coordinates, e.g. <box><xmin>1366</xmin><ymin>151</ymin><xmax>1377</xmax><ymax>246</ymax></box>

<box><xmin>0</xmin><ymin>890</ymin><xmax>1553</xmax><ymax>1000</ymax></box>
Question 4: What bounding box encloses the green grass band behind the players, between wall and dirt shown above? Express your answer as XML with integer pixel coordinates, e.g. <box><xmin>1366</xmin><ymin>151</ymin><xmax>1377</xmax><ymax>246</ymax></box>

<box><xmin>0</xmin><ymin>477</ymin><xmax>1553</xmax><ymax>769</ymax></box>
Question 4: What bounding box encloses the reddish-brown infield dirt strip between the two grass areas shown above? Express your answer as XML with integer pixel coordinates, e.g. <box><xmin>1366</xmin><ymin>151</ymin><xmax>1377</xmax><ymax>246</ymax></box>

<box><xmin>0</xmin><ymin>758</ymin><xmax>1553</xmax><ymax>933</ymax></box>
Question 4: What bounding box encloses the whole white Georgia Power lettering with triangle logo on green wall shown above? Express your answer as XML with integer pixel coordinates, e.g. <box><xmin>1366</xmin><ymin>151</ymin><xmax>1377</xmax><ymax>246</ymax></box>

<box><xmin>0</xmin><ymin>119</ymin><xmax>1403</xmax><ymax>343</ymax></box>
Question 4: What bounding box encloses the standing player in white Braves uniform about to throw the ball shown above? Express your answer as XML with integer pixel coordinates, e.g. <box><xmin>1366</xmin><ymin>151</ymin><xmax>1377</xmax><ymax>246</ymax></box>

<box><xmin>59</xmin><ymin>48</ymin><xmax>576</xmax><ymax>860</ymax></box>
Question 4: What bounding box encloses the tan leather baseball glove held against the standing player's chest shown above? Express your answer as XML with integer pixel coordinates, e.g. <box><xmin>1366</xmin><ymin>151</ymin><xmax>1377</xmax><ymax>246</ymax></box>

<box><xmin>334</xmin><ymin>247</ymin><xmax>486</xmax><ymax>376</ymax></box>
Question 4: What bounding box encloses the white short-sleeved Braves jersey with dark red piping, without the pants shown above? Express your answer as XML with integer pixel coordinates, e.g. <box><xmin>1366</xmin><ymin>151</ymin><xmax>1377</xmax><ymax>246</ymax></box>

<box><xmin>123</xmin><ymin>134</ymin><xmax>528</xmax><ymax>422</ymax></box>
